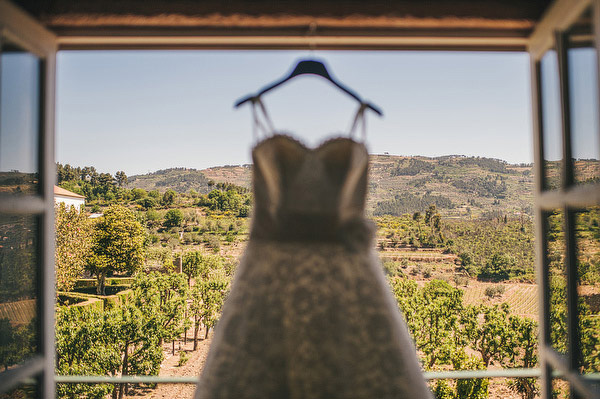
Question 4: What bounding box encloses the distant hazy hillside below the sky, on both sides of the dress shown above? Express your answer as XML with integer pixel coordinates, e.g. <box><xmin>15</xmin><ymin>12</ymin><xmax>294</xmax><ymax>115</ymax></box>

<box><xmin>128</xmin><ymin>155</ymin><xmax>533</xmax><ymax>217</ymax></box>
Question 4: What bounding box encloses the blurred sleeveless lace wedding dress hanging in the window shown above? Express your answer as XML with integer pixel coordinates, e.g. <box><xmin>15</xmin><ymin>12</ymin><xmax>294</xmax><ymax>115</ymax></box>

<box><xmin>196</xmin><ymin>135</ymin><xmax>431</xmax><ymax>399</ymax></box>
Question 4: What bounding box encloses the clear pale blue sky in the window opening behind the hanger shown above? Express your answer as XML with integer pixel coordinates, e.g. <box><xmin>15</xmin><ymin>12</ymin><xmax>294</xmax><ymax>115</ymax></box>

<box><xmin>56</xmin><ymin>51</ymin><xmax>533</xmax><ymax>175</ymax></box>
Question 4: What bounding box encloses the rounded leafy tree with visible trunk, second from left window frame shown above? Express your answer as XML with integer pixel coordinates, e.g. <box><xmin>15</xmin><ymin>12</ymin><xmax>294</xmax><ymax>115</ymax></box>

<box><xmin>87</xmin><ymin>206</ymin><xmax>146</xmax><ymax>295</ymax></box>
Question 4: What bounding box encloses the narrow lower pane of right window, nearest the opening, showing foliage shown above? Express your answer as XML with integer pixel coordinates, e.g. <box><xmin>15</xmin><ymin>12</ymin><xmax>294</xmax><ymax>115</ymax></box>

<box><xmin>546</xmin><ymin>211</ymin><xmax>567</xmax><ymax>353</ymax></box>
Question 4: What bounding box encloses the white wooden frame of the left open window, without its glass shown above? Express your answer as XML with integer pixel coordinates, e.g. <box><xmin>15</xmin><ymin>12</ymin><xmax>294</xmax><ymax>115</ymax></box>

<box><xmin>0</xmin><ymin>0</ymin><xmax>57</xmax><ymax>398</ymax></box>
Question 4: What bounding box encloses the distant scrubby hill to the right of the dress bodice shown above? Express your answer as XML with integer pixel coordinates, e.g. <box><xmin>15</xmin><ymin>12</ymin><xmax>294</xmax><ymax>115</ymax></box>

<box><xmin>368</xmin><ymin>155</ymin><xmax>534</xmax><ymax>217</ymax></box>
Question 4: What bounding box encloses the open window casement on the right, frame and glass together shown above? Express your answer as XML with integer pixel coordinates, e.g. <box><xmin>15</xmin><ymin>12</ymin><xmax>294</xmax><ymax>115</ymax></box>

<box><xmin>530</xmin><ymin>2</ymin><xmax>600</xmax><ymax>398</ymax></box>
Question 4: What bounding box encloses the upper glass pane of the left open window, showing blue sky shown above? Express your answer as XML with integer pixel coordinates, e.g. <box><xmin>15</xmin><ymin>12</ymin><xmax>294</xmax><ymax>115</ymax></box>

<box><xmin>0</xmin><ymin>44</ymin><xmax>40</xmax><ymax>194</ymax></box>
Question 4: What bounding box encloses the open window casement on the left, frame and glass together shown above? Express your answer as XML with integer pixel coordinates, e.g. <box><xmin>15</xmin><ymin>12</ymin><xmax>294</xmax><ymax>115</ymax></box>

<box><xmin>0</xmin><ymin>2</ymin><xmax>55</xmax><ymax>398</ymax></box>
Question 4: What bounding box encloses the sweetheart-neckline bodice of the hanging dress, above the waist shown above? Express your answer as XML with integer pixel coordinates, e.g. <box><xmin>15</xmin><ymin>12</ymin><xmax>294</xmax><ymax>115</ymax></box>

<box><xmin>252</xmin><ymin>135</ymin><xmax>369</xmax><ymax>245</ymax></box>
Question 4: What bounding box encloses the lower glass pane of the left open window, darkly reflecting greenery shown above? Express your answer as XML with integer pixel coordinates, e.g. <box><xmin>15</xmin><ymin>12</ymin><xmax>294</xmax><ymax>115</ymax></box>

<box><xmin>0</xmin><ymin>215</ymin><xmax>39</xmax><ymax>375</ymax></box>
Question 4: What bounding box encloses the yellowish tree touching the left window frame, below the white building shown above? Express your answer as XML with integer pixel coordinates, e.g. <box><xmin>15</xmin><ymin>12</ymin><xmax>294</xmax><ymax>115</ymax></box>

<box><xmin>54</xmin><ymin>203</ymin><xmax>92</xmax><ymax>291</ymax></box>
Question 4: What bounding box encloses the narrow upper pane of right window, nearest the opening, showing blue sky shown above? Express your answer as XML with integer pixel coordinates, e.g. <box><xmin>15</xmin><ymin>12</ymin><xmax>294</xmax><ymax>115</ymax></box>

<box><xmin>540</xmin><ymin>50</ymin><xmax>563</xmax><ymax>190</ymax></box>
